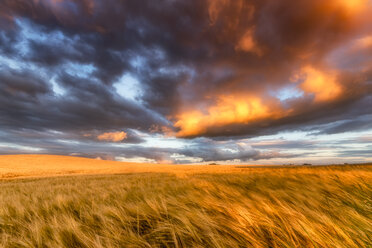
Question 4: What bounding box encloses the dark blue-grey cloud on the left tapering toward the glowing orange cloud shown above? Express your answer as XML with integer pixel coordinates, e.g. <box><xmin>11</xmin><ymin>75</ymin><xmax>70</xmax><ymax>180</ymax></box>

<box><xmin>0</xmin><ymin>68</ymin><xmax>164</xmax><ymax>132</ymax></box>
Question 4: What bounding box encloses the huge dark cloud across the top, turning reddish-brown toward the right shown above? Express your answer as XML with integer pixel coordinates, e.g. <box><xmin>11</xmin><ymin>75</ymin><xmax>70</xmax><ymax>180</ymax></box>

<box><xmin>1</xmin><ymin>0</ymin><xmax>370</xmax><ymax>70</ymax></box>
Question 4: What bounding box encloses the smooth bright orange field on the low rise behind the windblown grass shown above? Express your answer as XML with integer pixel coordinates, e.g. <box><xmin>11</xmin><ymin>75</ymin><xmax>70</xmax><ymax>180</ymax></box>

<box><xmin>0</xmin><ymin>155</ymin><xmax>241</xmax><ymax>179</ymax></box>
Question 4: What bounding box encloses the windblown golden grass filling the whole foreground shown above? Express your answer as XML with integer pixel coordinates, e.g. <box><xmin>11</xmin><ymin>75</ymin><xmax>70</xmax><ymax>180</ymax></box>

<box><xmin>0</xmin><ymin>166</ymin><xmax>372</xmax><ymax>248</ymax></box>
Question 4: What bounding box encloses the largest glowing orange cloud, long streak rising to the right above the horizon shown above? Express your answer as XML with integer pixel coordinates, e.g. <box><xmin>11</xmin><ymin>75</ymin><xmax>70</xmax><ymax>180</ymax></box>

<box><xmin>174</xmin><ymin>65</ymin><xmax>350</xmax><ymax>137</ymax></box>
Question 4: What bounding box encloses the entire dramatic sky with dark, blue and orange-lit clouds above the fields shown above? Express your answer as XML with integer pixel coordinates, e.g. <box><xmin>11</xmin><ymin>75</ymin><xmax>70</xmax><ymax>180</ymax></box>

<box><xmin>0</xmin><ymin>0</ymin><xmax>372</xmax><ymax>164</ymax></box>
